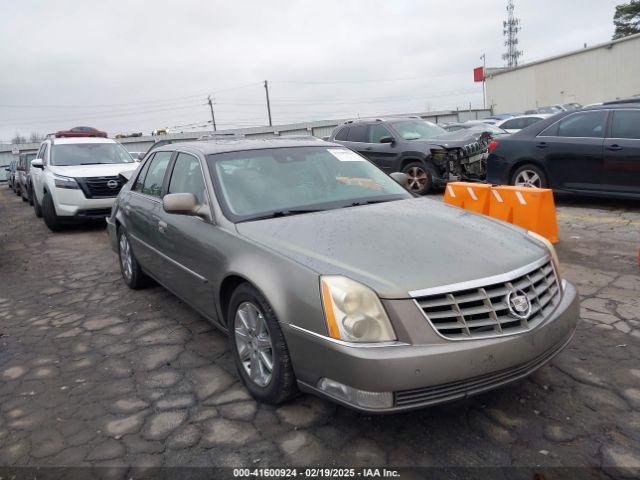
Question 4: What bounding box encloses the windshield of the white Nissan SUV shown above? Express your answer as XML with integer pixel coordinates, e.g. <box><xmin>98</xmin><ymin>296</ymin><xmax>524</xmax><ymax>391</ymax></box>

<box><xmin>51</xmin><ymin>143</ymin><xmax>133</xmax><ymax>166</ymax></box>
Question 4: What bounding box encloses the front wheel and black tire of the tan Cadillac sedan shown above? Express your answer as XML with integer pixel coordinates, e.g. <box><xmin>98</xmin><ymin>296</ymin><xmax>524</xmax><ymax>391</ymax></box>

<box><xmin>227</xmin><ymin>283</ymin><xmax>298</xmax><ymax>405</ymax></box>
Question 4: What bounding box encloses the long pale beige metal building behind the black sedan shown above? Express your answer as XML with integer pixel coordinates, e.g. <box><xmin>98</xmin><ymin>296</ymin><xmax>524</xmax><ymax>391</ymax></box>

<box><xmin>486</xmin><ymin>34</ymin><xmax>640</xmax><ymax>113</ymax></box>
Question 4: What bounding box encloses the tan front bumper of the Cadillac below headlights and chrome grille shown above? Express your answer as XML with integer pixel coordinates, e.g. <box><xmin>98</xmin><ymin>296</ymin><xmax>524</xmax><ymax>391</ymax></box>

<box><xmin>284</xmin><ymin>283</ymin><xmax>579</xmax><ymax>413</ymax></box>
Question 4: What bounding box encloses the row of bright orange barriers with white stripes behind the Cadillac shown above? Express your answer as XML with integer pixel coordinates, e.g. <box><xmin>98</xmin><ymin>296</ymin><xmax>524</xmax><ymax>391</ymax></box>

<box><xmin>444</xmin><ymin>182</ymin><xmax>558</xmax><ymax>243</ymax></box>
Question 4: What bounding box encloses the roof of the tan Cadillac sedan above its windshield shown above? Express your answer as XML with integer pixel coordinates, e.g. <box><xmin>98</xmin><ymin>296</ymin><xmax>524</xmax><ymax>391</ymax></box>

<box><xmin>155</xmin><ymin>137</ymin><xmax>345</xmax><ymax>155</ymax></box>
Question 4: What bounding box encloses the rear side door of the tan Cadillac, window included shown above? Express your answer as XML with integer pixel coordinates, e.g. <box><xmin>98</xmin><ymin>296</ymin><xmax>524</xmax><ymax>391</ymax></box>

<box><xmin>122</xmin><ymin>151</ymin><xmax>173</xmax><ymax>283</ymax></box>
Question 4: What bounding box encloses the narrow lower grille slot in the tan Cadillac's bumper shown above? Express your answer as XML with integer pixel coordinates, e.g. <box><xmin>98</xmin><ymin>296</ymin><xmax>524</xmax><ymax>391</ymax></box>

<box><xmin>394</xmin><ymin>339</ymin><xmax>570</xmax><ymax>407</ymax></box>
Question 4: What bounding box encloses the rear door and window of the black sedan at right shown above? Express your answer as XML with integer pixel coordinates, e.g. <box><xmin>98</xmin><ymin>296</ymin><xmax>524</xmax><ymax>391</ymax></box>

<box><xmin>534</xmin><ymin>110</ymin><xmax>608</xmax><ymax>191</ymax></box>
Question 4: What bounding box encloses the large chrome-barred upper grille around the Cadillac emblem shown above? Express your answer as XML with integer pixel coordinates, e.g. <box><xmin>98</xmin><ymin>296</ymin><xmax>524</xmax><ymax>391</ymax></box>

<box><xmin>415</xmin><ymin>261</ymin><xmax>560</xmax><ymax>340</ymax></box>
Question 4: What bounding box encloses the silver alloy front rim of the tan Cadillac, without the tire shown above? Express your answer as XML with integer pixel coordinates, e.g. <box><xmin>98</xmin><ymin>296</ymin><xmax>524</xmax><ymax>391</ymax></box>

<box><xmin>234</xmin><ymin>302</ymin><xmax>273</xmax><ymax>387</ymax></box>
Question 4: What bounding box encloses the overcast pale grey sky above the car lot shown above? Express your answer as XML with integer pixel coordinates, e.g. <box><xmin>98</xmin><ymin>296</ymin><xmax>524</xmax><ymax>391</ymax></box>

<box><xmin>0</xmin><ymin>0</ymin><xmax>622</xmax><ymax>140</ymax></box>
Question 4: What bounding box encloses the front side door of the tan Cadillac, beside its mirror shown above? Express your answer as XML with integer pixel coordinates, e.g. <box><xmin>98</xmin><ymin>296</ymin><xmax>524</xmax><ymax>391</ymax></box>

<box><xmin>157</xmin><ymin>152</ymin><xmax>215</xmax><ymax>315</ymax></box>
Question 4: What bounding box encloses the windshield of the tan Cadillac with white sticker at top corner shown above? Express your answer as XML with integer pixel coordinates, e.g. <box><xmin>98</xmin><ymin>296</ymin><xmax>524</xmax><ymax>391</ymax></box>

<box><xmin>207</xmin><ymin>147</ymin><xmax>411</xmax><ymax>221</ymax></box>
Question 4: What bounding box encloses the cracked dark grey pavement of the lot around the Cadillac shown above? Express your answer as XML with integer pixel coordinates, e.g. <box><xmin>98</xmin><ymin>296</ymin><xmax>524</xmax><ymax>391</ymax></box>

<box><xmin>0</xmin><ymin>185</ymin><xmax>640</xmax><ymax>478</ymax></box>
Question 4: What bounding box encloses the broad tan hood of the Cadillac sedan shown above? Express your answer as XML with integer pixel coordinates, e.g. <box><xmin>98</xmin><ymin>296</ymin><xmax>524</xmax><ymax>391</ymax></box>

<box><xmin>236</xmin><ymin>198</ymin><xmax>547</xmax><ymax>298</ymax></box>
